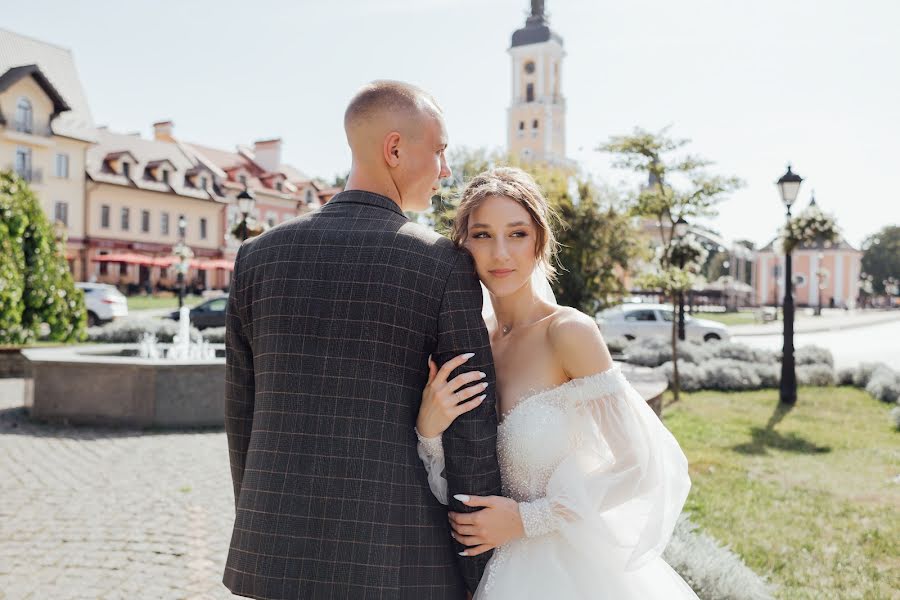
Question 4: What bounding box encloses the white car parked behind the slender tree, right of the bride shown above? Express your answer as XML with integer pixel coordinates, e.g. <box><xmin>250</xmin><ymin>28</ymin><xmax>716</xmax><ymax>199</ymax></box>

<box><xmin>597</xmin><ymin>304</ymin><xmax>731</xmax><ymax>342</ymax></box>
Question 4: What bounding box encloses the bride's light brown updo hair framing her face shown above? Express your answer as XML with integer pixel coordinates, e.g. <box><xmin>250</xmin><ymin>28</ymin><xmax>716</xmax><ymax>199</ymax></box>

<box><xmin>450</xmin><ymin>167</ymin><xmax>558</xmax><ymax>281</ymax></box>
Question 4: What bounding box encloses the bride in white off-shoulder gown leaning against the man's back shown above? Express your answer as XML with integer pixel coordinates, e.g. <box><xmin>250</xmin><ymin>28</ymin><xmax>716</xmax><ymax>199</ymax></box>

<box><xmin>416</xmin><ymin>168</ymin><xmax>696</xmax><ymax>600</ymax></box>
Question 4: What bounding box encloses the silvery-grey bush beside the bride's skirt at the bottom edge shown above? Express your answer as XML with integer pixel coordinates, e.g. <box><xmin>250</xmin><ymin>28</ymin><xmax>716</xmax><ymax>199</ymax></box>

<box><xmin>663</xmin><ymin>514</ymin><xmax>773</xmax><ymax>600</ymax></box>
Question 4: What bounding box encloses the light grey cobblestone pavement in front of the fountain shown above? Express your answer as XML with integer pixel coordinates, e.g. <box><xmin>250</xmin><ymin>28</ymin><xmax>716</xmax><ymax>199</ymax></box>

<box><xmin>0</xmin><ymin>380</ymin><xmax>234</xmax><ymax>600</ymax></box>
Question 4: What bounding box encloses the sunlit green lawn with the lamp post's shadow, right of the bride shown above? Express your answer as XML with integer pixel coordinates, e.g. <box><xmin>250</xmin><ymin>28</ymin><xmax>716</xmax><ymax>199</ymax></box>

<box><xmin>663</xmin><ymin>387</ymin><xmax>900</xmax><ymax>600</ymax></box>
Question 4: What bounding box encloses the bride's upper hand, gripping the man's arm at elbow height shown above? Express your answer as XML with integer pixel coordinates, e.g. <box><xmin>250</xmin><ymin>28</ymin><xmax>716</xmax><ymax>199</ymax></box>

<box><xmin>416</xmin><ymin>354</ymin><xmax>487</xmax><ymax>438</ymax></box>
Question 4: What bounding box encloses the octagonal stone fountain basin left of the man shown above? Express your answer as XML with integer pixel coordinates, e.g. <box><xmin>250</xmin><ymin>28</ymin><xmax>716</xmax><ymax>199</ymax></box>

<box><xmin>22</xmin><ymin>344</ymin><xmax>225</xmax><ymax>427</ymax></box>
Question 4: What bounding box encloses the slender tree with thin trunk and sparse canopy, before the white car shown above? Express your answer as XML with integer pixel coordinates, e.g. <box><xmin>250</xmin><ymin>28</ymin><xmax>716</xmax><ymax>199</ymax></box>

<box><xmin>600</xmin><ymin>128</ymin><xmax>742</xmax><ymax>402</ymax></box>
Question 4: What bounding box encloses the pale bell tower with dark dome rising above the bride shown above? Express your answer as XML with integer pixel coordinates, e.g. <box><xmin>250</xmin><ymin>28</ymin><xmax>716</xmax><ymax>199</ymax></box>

<box><xmin>507</xmin><ymin>0</ymin><xmax>566</xmax><ymax>163</ymax></box>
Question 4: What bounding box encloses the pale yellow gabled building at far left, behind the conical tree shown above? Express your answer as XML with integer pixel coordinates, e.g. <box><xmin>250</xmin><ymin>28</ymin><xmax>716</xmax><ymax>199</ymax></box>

<box><xmin>0</xmin><ymin>29</ymin><xmax>95</xmax><ymax>279</ymax></box>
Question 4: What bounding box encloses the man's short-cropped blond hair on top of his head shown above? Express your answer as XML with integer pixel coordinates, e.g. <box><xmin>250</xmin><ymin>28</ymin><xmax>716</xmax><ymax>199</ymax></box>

<box><xmin>344</xmin><ymin>79</ymin><xmax>441</xmax><ymax>133</ymax></box>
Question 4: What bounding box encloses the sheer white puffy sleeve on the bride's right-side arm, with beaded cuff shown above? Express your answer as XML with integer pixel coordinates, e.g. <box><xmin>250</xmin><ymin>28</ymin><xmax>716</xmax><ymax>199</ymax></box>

<box><xmin>519</xmin><ymin>366</ymin><xmax>691</xmax><ymax>570</ymax></box>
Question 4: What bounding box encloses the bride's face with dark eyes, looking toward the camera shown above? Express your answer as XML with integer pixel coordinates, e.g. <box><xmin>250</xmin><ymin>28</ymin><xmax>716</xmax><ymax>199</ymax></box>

<box><xmin>465</xmin><ymin>196</ymin><xmax>537</xmax><ymax>297</ymax></box>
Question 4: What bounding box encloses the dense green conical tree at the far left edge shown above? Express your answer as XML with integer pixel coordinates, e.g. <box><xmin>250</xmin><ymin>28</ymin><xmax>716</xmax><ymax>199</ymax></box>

<box><xmin>0</xmin><ymin>171</ymin><xmax>87</xmax><ymax>344</ymax></box>
